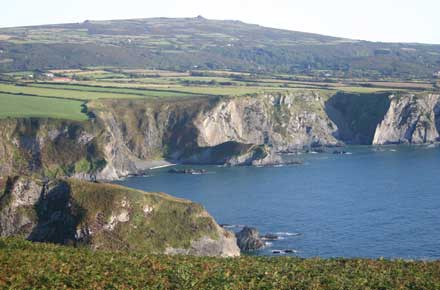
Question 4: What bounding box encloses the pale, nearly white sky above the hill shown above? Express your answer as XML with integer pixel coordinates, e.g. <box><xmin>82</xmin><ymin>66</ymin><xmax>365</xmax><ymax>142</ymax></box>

<box><xmin>0</xmin><ymin>0</ymin><xmax>440</xmax><ymax>44</ymax></box>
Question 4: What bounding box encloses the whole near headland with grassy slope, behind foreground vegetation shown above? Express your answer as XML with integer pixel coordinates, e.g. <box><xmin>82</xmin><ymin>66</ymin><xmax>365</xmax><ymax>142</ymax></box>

<box><xmin>0</xmin><ymin>177</ymin><xmax>240</xmax><ymax>257</ymax></box>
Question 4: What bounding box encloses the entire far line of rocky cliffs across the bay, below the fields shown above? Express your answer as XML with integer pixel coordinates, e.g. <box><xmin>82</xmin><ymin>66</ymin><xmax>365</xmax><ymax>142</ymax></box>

<box><xmin>0</xmin><ymin>90</ymin><xmax>440</xmax><ymax>180</ymax></box>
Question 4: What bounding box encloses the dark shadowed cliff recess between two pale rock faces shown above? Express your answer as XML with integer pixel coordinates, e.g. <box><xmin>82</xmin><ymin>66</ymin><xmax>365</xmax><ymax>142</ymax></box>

<box><xmin>325</xmin><ymin>92</ymin><xmax>390</xmax><ymax>145</ymax></box>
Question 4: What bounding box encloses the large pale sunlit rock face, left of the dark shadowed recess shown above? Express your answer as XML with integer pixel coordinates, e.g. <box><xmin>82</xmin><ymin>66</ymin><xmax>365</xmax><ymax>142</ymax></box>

<box><xmin>194</xmin><ymin>92</ymin><xmax>338</xmax><ymax>151</ymax></box>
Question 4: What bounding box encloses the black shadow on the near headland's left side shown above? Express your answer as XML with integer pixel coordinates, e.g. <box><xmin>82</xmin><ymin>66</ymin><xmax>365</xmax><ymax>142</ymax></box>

<box><xmin>28</xmin><ymin>181</ymin><xmax>85</xmax><ymax>244</ymax></box>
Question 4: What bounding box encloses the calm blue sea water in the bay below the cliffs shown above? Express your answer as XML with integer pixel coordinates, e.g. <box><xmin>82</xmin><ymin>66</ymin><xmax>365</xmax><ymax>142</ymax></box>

<box><xmin>115</xmin><ymin>147</ymin><xmax>440</xmax><ymax>259</ymax></box>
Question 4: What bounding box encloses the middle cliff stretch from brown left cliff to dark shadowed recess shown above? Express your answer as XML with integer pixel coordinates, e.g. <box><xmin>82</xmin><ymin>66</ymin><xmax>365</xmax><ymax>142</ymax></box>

<box><xmin>90</xmin><ymin>91</ymin><xmax>342</xmax><ymax>179</ymax></box>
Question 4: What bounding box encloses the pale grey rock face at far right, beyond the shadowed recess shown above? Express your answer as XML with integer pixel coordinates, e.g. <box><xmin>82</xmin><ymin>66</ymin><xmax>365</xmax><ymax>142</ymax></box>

<box><xmin>373</xmin><ymin>94</ymin><xmax>440</xmax><ymax>145</ymax></box>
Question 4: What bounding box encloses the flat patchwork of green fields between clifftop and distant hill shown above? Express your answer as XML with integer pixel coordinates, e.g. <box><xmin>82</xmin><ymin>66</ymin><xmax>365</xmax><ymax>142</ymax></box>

<box><xmin>0</xmin><ymin>67</ymin><xmax>434</xmax><ymax>120</ymax></box>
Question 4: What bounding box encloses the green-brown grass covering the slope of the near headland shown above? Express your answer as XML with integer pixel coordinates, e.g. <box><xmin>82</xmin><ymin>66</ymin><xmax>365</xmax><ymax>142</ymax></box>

<box><xmin>67</xmin><ymin>179</ymin><xmax>217</xmax><ymax>253</ymax></box>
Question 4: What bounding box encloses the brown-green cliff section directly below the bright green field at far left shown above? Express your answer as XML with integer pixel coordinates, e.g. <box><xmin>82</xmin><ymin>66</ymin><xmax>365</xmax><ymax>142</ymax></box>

<box><xmin>0</xmin><ymin>119</ymin><xmax>106</xmax><ymax>177</ymax></box>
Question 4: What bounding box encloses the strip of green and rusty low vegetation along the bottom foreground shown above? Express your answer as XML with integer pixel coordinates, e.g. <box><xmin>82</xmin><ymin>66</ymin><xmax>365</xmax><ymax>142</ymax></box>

<box><xmin>0</xmin><ymin>238</ymin><xmax>440</xmax><ymax>289</ymax></box>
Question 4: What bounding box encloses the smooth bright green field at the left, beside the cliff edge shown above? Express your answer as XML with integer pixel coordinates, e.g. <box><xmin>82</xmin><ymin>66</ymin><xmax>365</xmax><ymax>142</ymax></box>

<box><xmin>0</xmin><ymin>93</ymin><xmax>87</xmax><ymax>121</ymax></box>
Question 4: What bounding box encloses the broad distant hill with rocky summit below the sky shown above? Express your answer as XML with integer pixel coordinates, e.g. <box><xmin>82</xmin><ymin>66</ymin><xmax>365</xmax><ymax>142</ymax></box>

<box><xmin>0</xmin><ymin>17</ymin><xmax>440</xmax><ymax>78</ymax></box>
